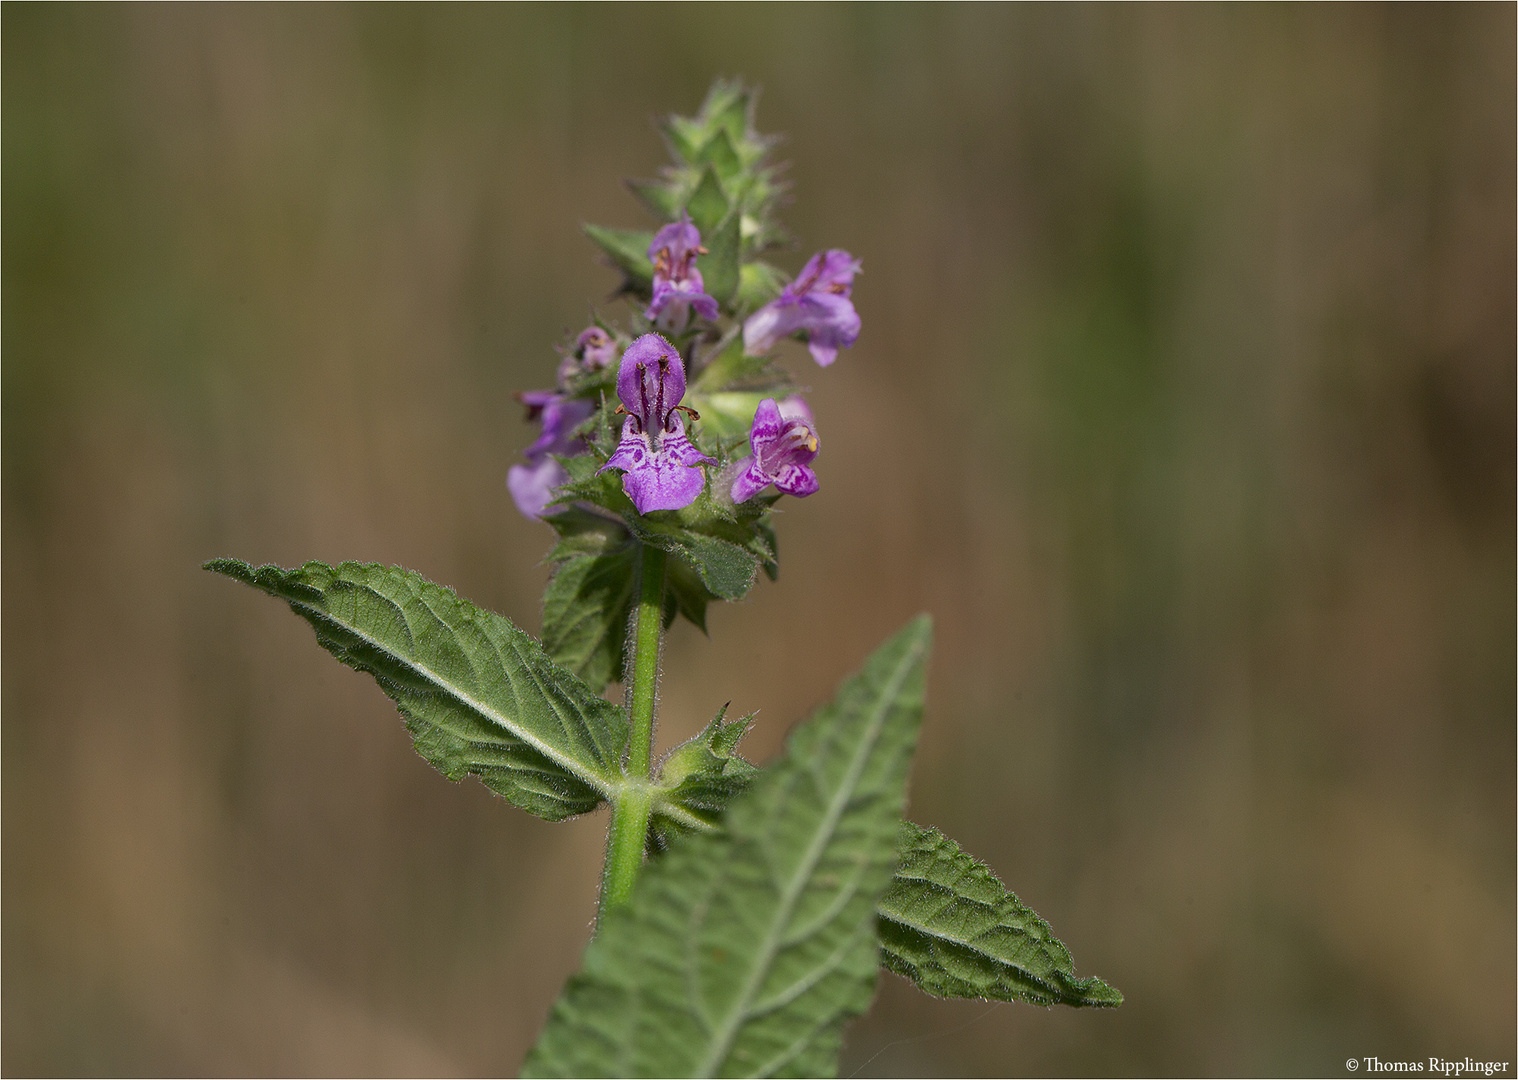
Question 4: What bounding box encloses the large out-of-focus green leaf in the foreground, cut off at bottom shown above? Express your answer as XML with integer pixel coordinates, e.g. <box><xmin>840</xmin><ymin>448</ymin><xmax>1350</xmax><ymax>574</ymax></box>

<box><xmin>522</xmin><ymin>617</ymin><xmax>931</xmax><ymax>1077</ymax></box>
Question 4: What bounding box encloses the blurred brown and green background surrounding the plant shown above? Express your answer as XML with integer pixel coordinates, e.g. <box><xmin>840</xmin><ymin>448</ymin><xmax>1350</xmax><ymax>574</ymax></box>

<box><xmin>0</xmin><ymin>5</ymin><xmax>1518</xmax><ymax>1075</ymax></box>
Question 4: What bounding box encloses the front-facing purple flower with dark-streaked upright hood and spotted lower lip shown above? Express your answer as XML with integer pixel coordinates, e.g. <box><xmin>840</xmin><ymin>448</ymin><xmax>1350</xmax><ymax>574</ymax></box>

<box><xmin>601</xmin><ymin>331</ymin><xmax>716</xmax><ymax>513</ymax></box>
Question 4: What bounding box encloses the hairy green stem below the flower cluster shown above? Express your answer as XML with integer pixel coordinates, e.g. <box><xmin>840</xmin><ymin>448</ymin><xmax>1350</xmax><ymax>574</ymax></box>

<box><xmin>598</xmin><ymin>544</ymin><xmax>665</xmax><ymax>921</ymax></box>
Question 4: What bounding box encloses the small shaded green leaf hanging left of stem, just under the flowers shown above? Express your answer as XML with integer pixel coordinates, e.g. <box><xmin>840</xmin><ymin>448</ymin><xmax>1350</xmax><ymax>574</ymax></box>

<box><xmin>543</xmin><ymin>507</ymin><xmax>638</xmax><ymax>694</ymax></box>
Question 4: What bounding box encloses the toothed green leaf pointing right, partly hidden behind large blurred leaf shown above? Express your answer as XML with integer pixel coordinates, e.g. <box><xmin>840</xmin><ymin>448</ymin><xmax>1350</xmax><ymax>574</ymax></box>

<box><xmin>879</xmin><ymin>822</ymin><xmax>1123</xmax><ymax>1007</ymax></box>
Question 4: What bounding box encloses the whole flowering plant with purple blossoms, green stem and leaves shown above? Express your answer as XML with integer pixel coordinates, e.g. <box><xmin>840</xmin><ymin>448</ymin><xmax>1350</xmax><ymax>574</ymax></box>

<box><xmin>206</xmin><ymin>82</ymin><xmax>1122</xmax><ymax>1075</ymax></box>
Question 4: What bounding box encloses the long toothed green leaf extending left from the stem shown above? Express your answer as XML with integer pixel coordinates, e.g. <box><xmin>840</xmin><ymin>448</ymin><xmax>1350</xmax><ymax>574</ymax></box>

<box><xmin>205</xmin><ymin>559</ymin><xmax>628</xmax><ymax>822</ymax></box>
